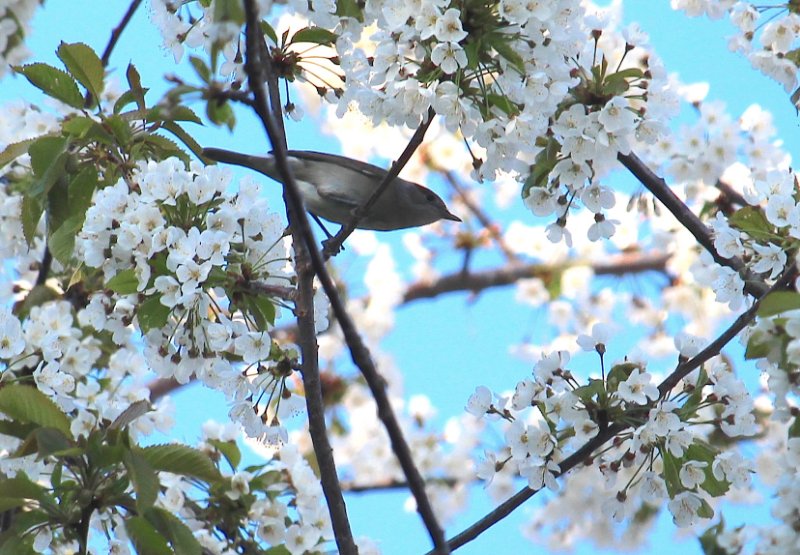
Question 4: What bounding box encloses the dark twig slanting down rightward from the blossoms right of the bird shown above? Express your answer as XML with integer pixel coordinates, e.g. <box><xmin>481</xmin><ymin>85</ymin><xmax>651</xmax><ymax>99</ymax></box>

<box><xmin>617</xmin><ymin>152</ymin><xmax>767</xmax><ymax>298</ymax></box>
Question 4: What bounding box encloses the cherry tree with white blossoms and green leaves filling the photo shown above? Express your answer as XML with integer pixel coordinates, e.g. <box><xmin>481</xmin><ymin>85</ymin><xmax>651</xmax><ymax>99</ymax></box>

<box><xmin>0</xmin><ymin>0</ymin><xmax>800</xmax><ymax>554</ymax></box>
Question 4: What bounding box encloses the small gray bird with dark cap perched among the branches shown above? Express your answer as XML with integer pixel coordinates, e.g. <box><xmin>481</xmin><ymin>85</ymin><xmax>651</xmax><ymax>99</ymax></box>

<box><xmin>203</xmin><ymin>148</ymin><xmax>461</xmax><ymax>231</ymax></box>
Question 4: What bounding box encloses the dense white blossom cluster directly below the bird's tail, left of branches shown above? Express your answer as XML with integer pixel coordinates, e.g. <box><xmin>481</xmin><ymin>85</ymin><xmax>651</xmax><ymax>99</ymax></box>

<box><xmin>77</xmin><ymin>158</ymin><xmax>310</xmax><ymax>439</ymax></box>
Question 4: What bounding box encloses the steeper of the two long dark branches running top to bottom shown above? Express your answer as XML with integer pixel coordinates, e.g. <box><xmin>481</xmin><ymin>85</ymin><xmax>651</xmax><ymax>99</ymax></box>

<box><xmin>239</xmin><ymin>0</ymin><xmax>358</xmax><ymax>555</ymax></box>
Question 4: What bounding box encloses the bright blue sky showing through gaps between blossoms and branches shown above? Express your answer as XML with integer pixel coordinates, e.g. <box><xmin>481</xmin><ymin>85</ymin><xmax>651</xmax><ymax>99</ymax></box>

<box><xmin>0</xmin><ymin>0</ymin><xmax>800</xmax><ymax>555</ymax></box>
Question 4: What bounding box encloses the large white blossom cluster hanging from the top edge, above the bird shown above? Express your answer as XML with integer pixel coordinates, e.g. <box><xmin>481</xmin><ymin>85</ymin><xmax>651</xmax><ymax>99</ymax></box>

<box><xmin>148</xmin><ymin>0</ymin><xmax>676</xmax><ymax>244</ymax></box>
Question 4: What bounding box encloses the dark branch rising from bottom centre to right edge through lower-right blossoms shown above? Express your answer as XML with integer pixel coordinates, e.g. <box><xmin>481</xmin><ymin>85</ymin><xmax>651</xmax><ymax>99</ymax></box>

<box><xmin>429</xmin><ymin>268</ymin><xmax>797</xmax><ymax>555</ymax></box>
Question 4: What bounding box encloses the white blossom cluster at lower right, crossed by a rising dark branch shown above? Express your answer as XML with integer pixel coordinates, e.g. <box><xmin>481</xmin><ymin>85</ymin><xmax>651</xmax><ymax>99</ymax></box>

<box><xmin>467</xmin><ymin>334</ymin><xmax>757</xmax><ymax>527</ymax></box>
